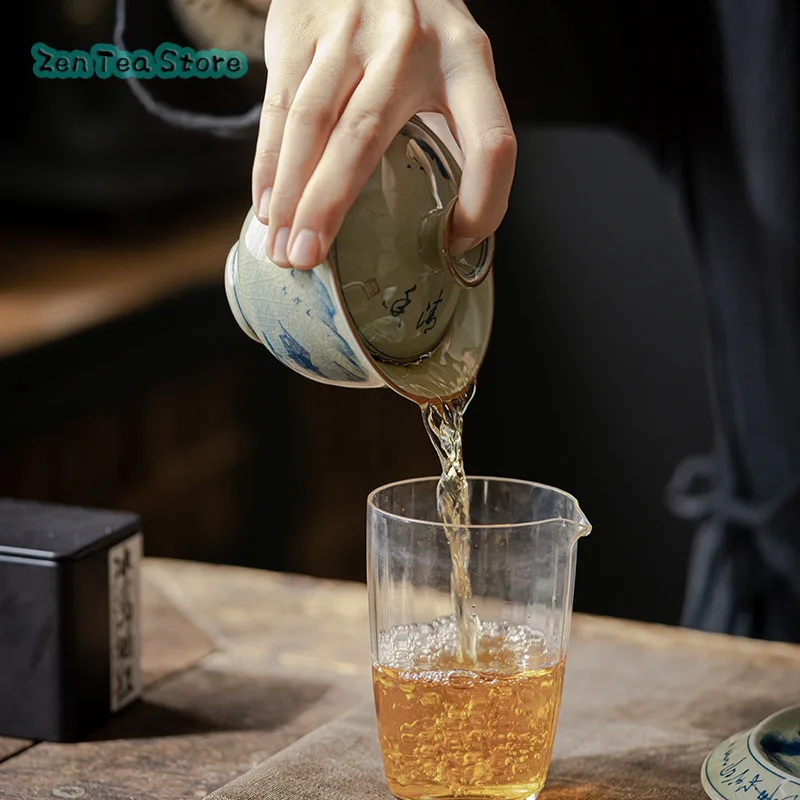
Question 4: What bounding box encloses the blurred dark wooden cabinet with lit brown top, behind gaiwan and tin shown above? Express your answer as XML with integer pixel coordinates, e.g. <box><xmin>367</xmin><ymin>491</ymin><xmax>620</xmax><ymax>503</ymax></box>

<box><xmin>0</xmin><ymin>214</ymin><xmax>437</xmax><ymax>579</ymax></box>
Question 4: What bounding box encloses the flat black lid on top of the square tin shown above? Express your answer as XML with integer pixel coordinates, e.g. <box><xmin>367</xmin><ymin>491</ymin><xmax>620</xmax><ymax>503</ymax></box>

<box><xmin>0</xmin><ymin>498</ymin><xmax>141</xmax><ymax>561</ymax></box>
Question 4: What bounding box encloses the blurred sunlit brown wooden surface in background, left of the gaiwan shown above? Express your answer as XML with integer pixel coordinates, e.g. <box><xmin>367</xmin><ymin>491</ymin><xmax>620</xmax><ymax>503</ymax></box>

<box><xmin>0</xmin><ymin>210</ymin><xmax>243</xmax><ymax>358</ymax></box>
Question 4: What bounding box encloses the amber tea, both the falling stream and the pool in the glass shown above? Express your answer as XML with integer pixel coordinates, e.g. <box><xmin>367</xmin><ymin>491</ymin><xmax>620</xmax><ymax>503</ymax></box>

<box><xmin>373</xmin><ymin>384</ymin><xmax>564</xmax><ymax>800</ymax></box>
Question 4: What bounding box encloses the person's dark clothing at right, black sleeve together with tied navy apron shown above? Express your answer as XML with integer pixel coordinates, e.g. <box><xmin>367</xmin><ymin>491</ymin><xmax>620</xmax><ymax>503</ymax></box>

<box><xmin>471</xmin><ymin>0</ymin><xmax>800</xmax><ymax>642</ymax></box>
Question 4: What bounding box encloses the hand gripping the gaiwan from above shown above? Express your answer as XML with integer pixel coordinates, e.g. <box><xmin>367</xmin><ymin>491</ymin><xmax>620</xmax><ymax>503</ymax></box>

<box><xmin>252</xmin><ymin>0</ymin><xmax>517</xmax><ymax>269</ymax></box>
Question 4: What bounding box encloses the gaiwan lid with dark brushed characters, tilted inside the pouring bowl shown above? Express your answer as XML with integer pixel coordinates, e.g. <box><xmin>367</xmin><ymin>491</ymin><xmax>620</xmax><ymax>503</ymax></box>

<box><xmin>331</xmin><ymin>117</ymin><xmax>494</xmax><ymax>364</ymax></box>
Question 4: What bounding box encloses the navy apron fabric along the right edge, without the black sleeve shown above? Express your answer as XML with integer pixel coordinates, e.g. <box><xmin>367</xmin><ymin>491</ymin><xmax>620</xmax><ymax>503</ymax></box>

<box><xmin>664</xmin><ymin>0</ymin><xmax>800</xmax><ymax>642</ymax></box>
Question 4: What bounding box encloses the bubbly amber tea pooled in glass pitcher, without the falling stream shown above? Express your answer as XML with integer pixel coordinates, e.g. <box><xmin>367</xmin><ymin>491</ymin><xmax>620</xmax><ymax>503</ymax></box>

<box><xmin>373</xmin><ymin>618</ymin><xmax>564</xmax><ymax>800</ymax></box>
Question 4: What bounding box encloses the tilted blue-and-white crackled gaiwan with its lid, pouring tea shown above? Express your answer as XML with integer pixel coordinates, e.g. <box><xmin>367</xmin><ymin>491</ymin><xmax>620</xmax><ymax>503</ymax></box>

<box><xmin>225</xmin><ymin>118</ymin><xmax>494</xmax><ymax>402</ymax></box>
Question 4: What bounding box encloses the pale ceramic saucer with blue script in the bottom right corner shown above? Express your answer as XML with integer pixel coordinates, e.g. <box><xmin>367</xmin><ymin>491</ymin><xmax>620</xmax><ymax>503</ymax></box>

<box><xmin>700</xmin><ymin>705</ymin><xmax>800</xmax><ymax>800</ymax></box>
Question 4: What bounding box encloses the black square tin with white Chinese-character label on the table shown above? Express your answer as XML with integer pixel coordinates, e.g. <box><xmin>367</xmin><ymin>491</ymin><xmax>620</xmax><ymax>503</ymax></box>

<box><xmin>0</xmin><ymin>499</ymin><xmax>142</xmax><ymax>742</ymax></box>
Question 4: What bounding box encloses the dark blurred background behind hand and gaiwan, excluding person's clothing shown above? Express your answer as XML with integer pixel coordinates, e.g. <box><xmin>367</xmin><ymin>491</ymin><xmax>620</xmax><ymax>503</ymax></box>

<box><xmin>0</xmin><ymin>0</ymin><xmax>710</xmax><ymax>623</ymax></box>
